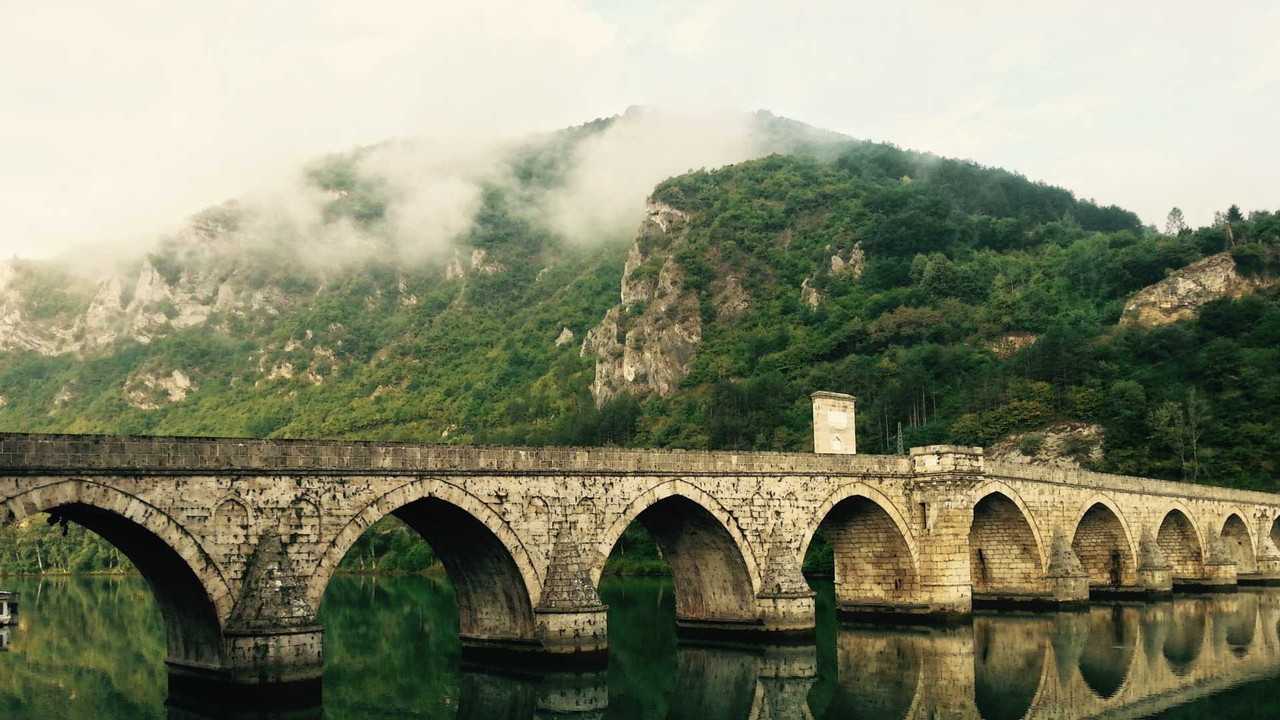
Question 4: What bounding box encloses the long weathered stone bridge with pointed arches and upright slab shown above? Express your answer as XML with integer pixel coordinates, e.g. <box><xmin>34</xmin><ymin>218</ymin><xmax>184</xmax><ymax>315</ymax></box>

<box><xmin>0</xmin><ymin>393</ymin><xmax>1280</xmax><ymax>684</ymax></box>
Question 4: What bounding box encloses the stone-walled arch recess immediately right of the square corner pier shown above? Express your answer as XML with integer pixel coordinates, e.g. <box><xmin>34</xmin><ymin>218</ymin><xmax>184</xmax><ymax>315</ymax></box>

<box><xmin>969</xmin><ymin>483</ymin><xmax>1044</xmax><ymax>593</ymax></box>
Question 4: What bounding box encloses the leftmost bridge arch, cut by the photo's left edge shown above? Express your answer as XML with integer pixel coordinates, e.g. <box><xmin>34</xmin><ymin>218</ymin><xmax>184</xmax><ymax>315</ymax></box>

<box><xmin>0</xmin><ymin>479</ymin><xmax>234</xmax><ymax>666</ymax></box>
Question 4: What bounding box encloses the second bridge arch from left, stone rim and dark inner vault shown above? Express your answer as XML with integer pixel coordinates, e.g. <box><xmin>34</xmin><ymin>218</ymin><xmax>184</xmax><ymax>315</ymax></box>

<box><xmin>307</xmin><ymin>478</ymin><xmax>543</xmax><ymax>643</ymax></box>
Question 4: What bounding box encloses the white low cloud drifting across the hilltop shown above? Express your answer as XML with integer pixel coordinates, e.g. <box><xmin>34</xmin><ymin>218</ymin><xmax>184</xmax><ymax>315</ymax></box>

<box><xmin>110</xmin><ymin>109</ymin><xmax>771</xmax><ymax>272</ymax></box>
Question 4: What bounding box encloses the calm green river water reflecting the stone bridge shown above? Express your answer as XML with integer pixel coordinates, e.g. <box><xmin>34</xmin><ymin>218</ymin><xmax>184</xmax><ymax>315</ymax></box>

<box><xmin>0</xmin><ymin>577</ymin><xmax>1280</xmax><ymax>720</ymax></box>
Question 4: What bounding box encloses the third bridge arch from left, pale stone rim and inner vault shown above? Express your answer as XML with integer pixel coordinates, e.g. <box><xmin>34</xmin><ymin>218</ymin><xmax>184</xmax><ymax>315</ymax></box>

<box><xmin>590</xmin><ymin>479</ymin><xmax>762</xmax><ymax>621</ymax></box>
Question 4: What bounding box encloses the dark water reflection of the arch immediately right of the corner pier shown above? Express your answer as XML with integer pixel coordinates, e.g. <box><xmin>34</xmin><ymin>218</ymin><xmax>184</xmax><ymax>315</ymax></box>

<box><xmin>973</xmin><ymin>616</ymin><xmax>1047</xmax><ymax>720</ymax></box>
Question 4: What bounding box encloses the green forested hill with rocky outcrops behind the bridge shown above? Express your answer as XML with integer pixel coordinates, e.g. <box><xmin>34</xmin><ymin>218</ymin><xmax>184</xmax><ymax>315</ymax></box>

<box><xmin>0</xmin><ymin>110</ymin><xmax>1280</xmax><ymax>499</ymax></box>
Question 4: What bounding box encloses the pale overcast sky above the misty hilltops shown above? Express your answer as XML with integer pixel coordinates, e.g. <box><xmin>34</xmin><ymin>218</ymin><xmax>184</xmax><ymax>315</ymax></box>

<box><xmin>0</xmin><ymin>0</ymin><xmax>1280</xmax><ymax>256</ymax></box>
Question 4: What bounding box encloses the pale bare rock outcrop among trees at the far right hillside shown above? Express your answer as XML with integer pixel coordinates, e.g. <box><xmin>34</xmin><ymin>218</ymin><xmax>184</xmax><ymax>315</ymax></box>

<box><xmin>1120</xmin><ymin>252</ymin><xmax>1274</xmax><ymax>327</ymax></box>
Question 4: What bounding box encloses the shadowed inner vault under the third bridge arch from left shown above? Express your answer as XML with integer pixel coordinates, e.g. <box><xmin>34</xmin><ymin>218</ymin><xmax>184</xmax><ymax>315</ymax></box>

<box><xmin>596</xmin><ymin>488</ymin><xmax>758</xmax><ymax>623</ymax></box>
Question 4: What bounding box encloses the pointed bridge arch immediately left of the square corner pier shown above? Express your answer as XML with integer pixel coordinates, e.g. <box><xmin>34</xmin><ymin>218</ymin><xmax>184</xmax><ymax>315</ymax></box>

<box><xmin>801</xmin><ymin>483</ymin><xmax>920</xmax><ymax>605</ymax></box>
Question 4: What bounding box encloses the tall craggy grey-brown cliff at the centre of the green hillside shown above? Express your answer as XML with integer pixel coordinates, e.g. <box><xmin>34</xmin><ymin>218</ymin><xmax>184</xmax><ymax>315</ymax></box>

<box><xmin>581</xmin><ymin>202</ymin><xmax>706</xmax><ymax>405</ymax></box>
